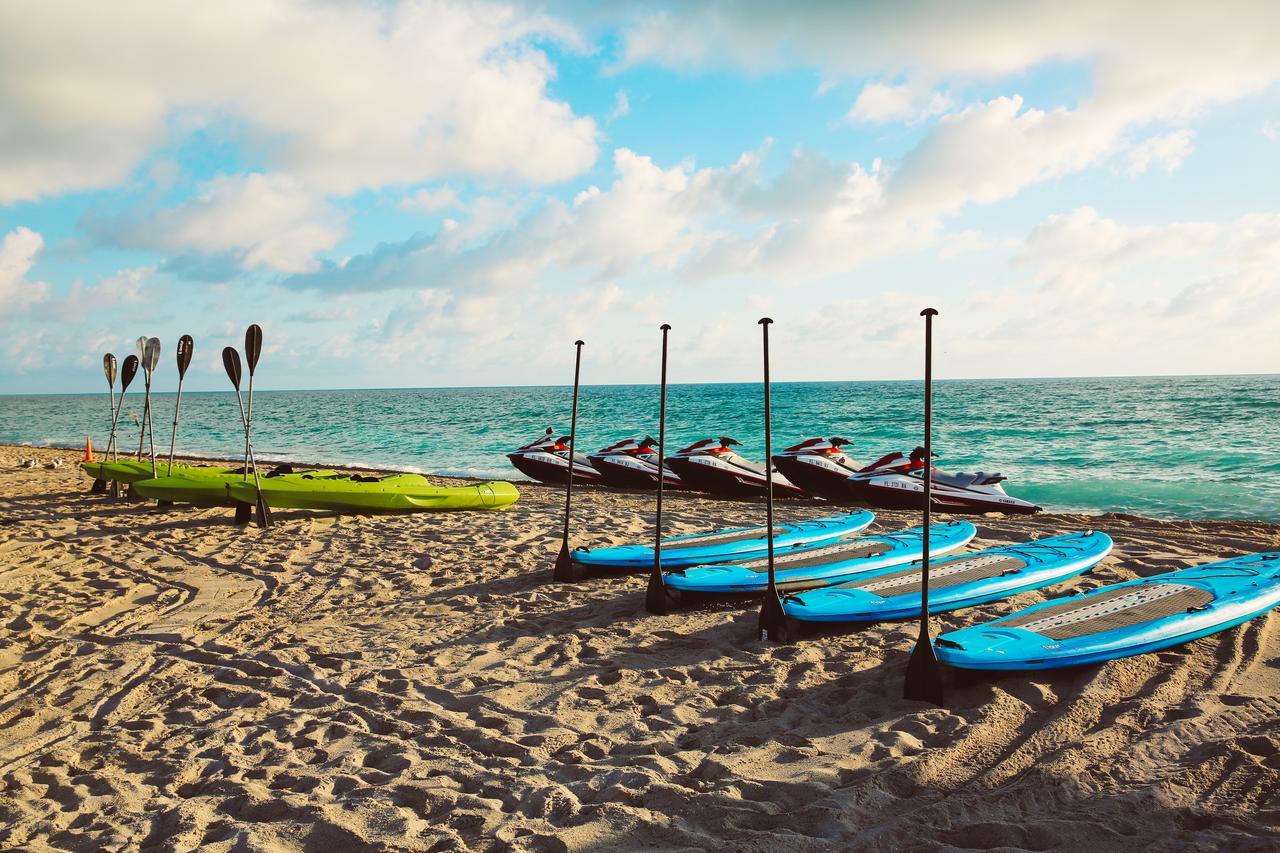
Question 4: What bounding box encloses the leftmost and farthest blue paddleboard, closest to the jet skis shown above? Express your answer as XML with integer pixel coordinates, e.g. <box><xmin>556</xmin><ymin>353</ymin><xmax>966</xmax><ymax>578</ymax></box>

<box><xmin>572</xmin><ymin>510</ymin><xmax>876</xmax><ymax>569</ymax></box>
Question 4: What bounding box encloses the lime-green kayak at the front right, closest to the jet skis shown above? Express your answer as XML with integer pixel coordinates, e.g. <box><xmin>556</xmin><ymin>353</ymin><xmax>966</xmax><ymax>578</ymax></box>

<box><xmin>227</xmin><ymin>473</ymin><xmax>520</xmax><ymax>512</ymax></box>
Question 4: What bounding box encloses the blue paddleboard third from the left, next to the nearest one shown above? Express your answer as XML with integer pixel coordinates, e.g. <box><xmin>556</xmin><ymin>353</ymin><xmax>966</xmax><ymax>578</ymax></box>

<box><xmin>782</xmin><ymin>530</ymin><xmax>1111</xmax><ymax>622</ymax></box>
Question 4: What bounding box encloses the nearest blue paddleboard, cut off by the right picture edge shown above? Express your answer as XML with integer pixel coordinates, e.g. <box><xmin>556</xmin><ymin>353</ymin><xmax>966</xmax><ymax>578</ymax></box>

<box><xmin>934</xmin><ymin>552</ymin><xmax>1280</xmax><ymax>670</ymax></box>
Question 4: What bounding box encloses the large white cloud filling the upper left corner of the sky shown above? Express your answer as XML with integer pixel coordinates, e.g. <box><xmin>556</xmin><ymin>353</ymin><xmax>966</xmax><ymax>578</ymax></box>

<box><xmin>0</xmin><ymin>0</ymin><xmax>596</xmax><ymax>204</ymax></box>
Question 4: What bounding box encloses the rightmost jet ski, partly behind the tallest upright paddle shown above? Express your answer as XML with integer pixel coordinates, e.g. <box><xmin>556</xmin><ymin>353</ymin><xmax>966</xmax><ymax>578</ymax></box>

<box><xmin>847</xmin><ymin>447</ymin><xmax>1041</xmax><ymax>515</ymax></box>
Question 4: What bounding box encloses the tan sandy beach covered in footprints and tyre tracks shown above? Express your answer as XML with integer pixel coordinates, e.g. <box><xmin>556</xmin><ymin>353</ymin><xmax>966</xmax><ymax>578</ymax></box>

<box><xmin>0</xmin><ymin>447</ymin><xmax>1280</xmax><ymax>852</ymax></box>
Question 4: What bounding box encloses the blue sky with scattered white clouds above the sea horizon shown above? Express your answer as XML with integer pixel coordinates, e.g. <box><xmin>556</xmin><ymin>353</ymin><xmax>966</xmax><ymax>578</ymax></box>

<box><xmin>0</xmin><ymin>0</ymin><xmax>1280</xmax><ymax>393</ymax></box>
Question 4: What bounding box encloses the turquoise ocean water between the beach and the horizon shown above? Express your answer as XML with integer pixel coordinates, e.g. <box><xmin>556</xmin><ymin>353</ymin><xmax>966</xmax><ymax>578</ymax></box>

<box><xmin>0</xmin><ymin>375</ymin><xmax>1280</xmax><ymax>521</ymax></box>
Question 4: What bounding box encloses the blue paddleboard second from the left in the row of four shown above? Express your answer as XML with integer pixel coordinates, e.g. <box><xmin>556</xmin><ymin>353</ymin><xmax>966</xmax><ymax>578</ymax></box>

<box><xmin>662</xmin><ymin>521</ymin><xmax>978</xmax><ymax>593</ymax></box>
